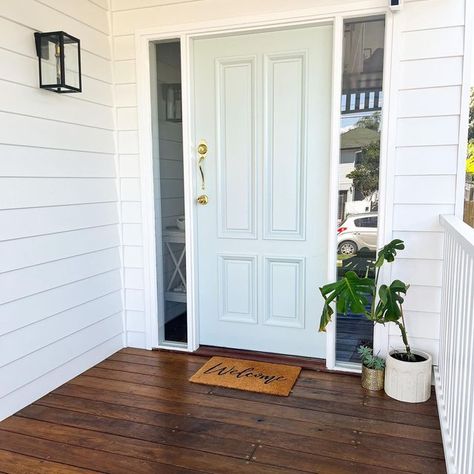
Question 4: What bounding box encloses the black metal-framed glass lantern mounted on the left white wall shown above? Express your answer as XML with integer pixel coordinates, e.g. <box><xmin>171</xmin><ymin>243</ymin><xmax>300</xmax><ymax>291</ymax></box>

<box><xmin>35</xmin><ymin>31</ymin><xmax>82</xmax><ymax>93</ymax></box>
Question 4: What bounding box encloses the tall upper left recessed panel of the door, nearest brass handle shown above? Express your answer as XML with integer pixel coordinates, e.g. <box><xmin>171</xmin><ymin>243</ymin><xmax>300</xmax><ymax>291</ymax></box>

<box><xmin>216</xmin><ymin>56</ymin><xmax>257</xmax><ymax>239</ymax></box>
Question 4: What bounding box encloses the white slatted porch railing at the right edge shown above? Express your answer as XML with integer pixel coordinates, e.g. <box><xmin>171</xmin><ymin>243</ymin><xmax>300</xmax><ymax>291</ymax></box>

<box><xmin>435</xmin><ymin>216</ymin><xmax>474</xmax><ymax>474</ymax></box>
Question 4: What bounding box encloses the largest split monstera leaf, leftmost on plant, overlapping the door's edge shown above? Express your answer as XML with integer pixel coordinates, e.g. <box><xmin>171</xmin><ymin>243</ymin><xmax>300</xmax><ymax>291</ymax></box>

<box><xmin>319</xmin><ymin>272</ymin><xmax>374</xmax><ymax>331</ymax></box>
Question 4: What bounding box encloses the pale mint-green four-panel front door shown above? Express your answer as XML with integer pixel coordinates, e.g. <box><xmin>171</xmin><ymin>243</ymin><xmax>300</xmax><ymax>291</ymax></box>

<box><xmin>193</xmin><ymin>26</ymin><xmax>332</xmax><ymax>357</ymax></box>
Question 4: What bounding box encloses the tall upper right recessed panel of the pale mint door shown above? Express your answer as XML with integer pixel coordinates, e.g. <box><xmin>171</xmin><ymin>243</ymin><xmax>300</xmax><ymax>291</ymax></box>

<box><xmin>264</xmin><ymin>52</ymin><xmax>308</xmax><ymax>240</ymax></box>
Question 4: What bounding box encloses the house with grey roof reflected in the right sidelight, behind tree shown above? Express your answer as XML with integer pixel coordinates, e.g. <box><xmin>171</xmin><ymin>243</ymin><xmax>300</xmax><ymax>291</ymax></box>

<box><xmin>338</xmin><ymin>127</ymin><xmax>380</xmax><ymax>221</ymax></box>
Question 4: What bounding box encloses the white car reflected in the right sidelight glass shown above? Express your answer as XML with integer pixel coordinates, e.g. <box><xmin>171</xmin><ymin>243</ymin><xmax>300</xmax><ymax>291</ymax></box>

<box><xmin>337</xmin><ymin>213</ymin><xmax>377</xmax><ymax>255</ymax></box>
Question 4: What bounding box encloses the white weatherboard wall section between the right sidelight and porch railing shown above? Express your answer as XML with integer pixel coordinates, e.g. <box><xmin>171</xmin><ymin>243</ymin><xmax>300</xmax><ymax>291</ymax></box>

<box><xmin>390</xmin><ymin>0</ymin><xmax>465</xmax><ymax>364</ymax></box>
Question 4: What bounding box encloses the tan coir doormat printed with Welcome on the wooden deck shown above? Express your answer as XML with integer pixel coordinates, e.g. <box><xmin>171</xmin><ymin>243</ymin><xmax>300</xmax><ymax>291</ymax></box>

<box><xmin>189</xmin><ymin>357</ymin><xmax>301</xmax><ymax>397</ymax></box>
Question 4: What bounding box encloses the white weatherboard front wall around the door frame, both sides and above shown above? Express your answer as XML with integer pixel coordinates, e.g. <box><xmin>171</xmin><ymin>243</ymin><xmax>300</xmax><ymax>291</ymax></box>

<box><xmin>111</xmin><ymin>0</ymin><xmax>470</xmax><ymax>361</ymax></box>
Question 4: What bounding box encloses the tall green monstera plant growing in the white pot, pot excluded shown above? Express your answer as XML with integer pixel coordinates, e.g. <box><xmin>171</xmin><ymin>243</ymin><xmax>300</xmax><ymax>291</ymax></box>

<box><xmin>319</xmin><ymin>239</ymin><xmax>415</xmax><ymax>361</ymax></box>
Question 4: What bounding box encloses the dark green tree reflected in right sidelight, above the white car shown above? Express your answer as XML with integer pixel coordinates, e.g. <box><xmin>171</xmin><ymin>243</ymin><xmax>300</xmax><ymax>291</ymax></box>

<box><xmin>347</xmin><ymin>140</ymin><xmax>380</xmax><ymax>199</ymax></box>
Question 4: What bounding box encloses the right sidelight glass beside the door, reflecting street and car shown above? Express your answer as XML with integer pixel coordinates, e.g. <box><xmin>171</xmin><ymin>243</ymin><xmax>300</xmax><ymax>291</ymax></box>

<box><xmin>336</xmin><ymin>14</ymin><xmax>385</xmax><ymax>363</ymax></box>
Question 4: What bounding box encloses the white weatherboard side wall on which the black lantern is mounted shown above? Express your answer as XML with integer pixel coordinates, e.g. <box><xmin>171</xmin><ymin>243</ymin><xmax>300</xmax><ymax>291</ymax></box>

<box><xmin>0</xmin><ymin>0</ymin><xmax>127</xmax><ymax>419</ymax></box>
